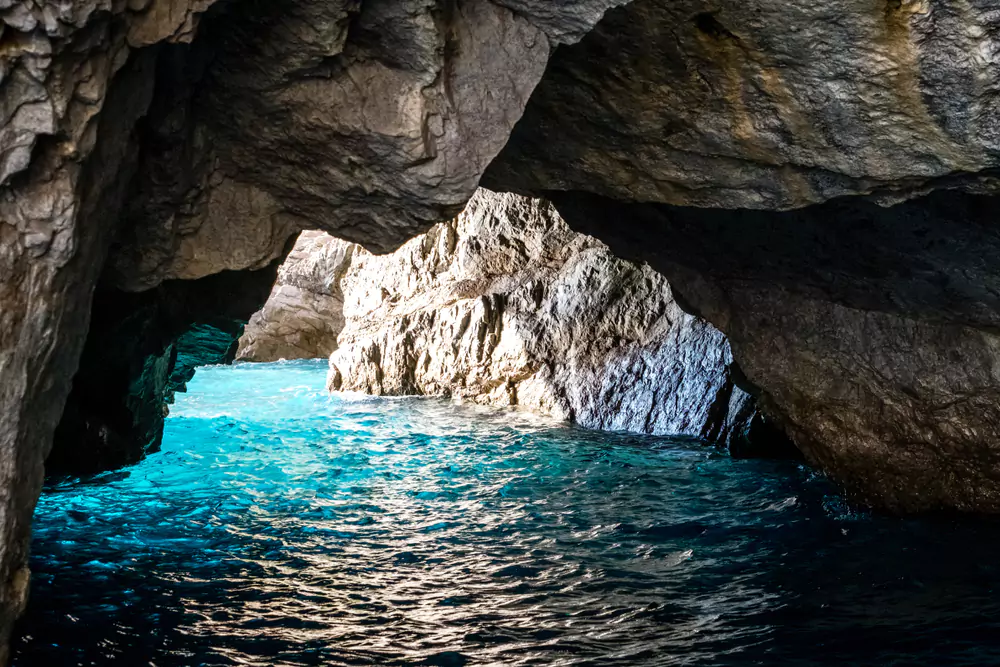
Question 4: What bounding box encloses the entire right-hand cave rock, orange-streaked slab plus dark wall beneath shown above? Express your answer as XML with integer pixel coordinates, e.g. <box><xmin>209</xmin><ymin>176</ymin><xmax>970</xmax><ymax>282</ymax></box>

<box><xmin>484</xmin><ymin>0</ymin><xmax>1000</xmax><ymax>512</ymax></box>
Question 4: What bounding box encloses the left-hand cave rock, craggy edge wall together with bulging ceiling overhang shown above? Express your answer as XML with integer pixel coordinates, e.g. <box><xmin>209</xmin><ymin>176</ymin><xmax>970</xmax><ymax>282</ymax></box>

<box><xmin>0</xmin><ymin>0</ymin><xmax>615</xmax><ymax>662</ymax></box>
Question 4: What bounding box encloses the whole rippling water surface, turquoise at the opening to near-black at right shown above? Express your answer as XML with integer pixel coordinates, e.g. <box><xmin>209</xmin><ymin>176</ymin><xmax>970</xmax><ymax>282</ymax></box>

<box><xmin>14</xmin><ymin>362</ymin><xmax>1000</xmax><ymax>667</ymax></box>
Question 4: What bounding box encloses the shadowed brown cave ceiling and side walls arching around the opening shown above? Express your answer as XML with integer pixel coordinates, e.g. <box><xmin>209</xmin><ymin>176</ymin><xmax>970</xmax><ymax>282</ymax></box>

<box><xmin>7</xmin><ymin>0</ymin><xmax>1000</xmax><ymax>659</ymax></box>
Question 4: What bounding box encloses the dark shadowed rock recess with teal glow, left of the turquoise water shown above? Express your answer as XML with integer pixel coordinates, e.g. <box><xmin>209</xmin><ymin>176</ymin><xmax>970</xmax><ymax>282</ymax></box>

<box><xmin>45</xmin><ymin>262</ymin><xmax>288</xmax><ymax>475</ymax></box>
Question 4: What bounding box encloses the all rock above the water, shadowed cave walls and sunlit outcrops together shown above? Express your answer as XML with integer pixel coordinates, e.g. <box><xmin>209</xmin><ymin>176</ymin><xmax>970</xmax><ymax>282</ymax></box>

<box><xmin>9</xmin><ymin>0</ymin><xmax>1000</xmax><ymax>664</ymax></box>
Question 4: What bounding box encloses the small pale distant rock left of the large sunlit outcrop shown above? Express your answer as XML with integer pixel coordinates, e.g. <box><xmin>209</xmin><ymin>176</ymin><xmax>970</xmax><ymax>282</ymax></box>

<box><xmin>236</xmin><ymin>231</ymin><xmax>359</xmax><ymax>361</ymax></box>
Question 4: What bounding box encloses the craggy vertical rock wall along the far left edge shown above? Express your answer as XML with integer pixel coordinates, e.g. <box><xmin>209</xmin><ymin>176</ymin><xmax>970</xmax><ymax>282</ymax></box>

<box><xmin>0</xmin><ymin>19</ymin><xmax>162</xmax><ymax>663</ymax></box>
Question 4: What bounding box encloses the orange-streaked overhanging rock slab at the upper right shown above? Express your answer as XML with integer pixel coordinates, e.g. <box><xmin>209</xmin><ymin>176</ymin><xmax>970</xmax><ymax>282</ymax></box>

<box><xmin>486</xmin><ymin>0</ymin><xmax>1000</xmax><ymax>210</ymax></box>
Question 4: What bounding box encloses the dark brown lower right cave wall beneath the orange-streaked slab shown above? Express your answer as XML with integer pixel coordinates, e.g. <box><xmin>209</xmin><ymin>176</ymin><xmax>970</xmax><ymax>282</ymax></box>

<box><xmin>553</xmin><ymin>192</ymin><xmax>1000</xmax><ymax>511</ymax></box>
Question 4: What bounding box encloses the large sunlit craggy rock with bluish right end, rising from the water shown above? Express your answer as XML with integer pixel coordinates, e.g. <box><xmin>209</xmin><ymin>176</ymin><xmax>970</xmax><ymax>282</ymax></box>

<box><xmin>329</xmin><ymin>190</ymin><xmax>772</xmax><ymax>447</ymax></box>
